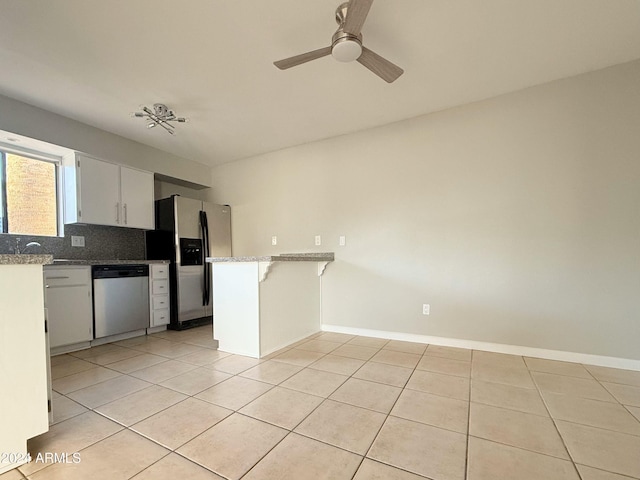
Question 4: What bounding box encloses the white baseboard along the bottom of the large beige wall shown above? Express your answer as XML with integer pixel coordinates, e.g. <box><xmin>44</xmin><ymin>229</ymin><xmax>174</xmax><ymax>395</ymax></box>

<box><xmin>322</xmin><ymin>324</ymin><xmax>640</xmax><ymax>371</ymax></box>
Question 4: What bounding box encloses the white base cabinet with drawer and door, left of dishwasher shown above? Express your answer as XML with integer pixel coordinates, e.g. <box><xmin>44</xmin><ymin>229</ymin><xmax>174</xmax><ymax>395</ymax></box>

<box><xmin>44</xmin><ymin>266</ymin><xmax>93</xmax><ymax>354</ymax></box>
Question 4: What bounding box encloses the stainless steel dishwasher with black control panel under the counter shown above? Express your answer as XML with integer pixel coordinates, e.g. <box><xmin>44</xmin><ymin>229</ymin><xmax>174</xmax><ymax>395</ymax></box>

<box><xmin>92</xmin><ymin>265</ymin><xmax>149</xmax><ymax>338</ymax></box>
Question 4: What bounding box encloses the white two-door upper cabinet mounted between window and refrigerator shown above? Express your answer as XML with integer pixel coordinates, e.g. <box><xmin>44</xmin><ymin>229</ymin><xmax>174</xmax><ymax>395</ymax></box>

<box><xmin>64</xmin><ymin>154</ymin><xmax>154</xmax><ymax>230</ymax></box>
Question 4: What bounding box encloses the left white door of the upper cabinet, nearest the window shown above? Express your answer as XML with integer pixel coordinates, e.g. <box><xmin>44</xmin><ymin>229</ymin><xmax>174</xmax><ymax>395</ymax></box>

<box><xmin>76</xmin><ymin>155</ymin><xmax>121</xmax><ymax>225</ymax></box>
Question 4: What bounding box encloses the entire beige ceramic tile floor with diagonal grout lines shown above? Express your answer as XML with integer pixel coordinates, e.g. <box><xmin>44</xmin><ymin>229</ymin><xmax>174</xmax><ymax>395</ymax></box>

<box><xmin>0</xmin><ymin>326</ymin><xmax>640</xmax><ymax>480</ymax></box>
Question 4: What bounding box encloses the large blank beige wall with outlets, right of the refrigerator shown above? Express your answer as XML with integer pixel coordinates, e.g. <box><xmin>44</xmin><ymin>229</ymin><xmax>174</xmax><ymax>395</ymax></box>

<box><xmin>210</xmin><ymin>62</ymin><xmax>640</xmax><ymax>359</ymax></box>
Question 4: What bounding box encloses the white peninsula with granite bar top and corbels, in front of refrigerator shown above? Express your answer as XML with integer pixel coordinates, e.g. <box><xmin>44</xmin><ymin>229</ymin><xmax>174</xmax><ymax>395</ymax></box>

<box><xmin>207</xmin><ymin>253</ymin><xmax>334</xmax><ymax>358</ymax></box>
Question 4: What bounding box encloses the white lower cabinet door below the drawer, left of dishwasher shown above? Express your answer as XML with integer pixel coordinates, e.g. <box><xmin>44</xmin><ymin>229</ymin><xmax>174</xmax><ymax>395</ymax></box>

<box><xmin>45</xmin><ymin>285</ymin><xmax>93</xmax><ymax>348</ymax></box>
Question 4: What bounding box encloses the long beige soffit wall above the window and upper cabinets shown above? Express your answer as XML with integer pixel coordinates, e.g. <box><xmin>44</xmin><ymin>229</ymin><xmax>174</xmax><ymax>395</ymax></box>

<box><xmin>0</xmin><ymin>95</ymin><xmax>210</xmax><ymax>187</ymax></box>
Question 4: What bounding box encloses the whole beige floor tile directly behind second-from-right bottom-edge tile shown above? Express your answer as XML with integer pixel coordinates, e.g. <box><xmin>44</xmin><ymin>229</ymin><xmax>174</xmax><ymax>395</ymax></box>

<box><xmin>469</xmin><ymin>403</ymin><xmax>569</xmax><ymax>460</ymax></box>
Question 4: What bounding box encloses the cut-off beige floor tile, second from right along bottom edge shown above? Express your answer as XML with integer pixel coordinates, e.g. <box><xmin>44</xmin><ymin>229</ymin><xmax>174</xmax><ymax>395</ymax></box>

<box><xmin>467</xmin><ymin>437</ymin><xmax>580</xmax><ymax>480</ymax></box>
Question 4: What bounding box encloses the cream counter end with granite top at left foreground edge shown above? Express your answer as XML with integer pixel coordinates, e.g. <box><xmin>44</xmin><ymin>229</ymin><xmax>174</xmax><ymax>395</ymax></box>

<box><xmin>0</xmin><ymin>255</ymin><xmax>53</xmax><ymax>474</ymax></box>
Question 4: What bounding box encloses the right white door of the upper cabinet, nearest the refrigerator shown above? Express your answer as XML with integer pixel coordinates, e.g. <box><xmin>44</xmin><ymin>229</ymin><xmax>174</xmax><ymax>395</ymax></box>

<box><xmin>120</xmin><ymin>166</ymin><xmax>155</xmax><ymax>230</ymax></box>
